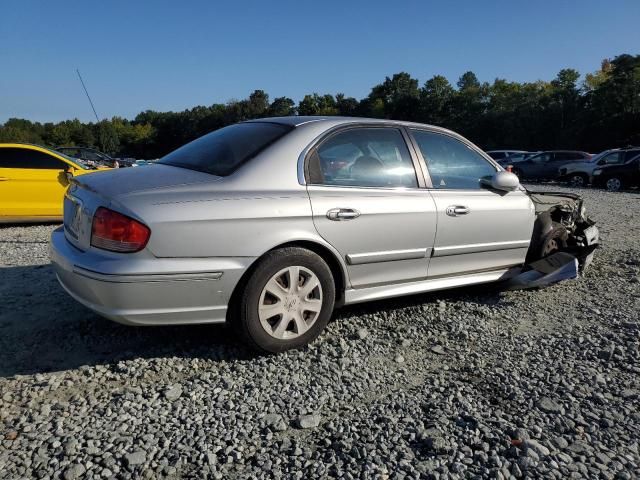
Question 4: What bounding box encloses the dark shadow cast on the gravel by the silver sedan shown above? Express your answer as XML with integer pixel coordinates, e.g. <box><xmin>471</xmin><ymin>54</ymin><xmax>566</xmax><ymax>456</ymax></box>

<box><xmin>0</xmin><ymin>265</ymin><xmax>504</xmax><ymax>377</ymax></box>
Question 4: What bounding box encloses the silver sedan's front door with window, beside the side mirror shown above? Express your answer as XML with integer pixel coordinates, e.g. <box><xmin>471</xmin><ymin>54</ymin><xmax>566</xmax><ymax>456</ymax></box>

<box><xmin>411</xmin><ymin>129</ymin><xmax>535</xmax><ymax>278</ymax></box>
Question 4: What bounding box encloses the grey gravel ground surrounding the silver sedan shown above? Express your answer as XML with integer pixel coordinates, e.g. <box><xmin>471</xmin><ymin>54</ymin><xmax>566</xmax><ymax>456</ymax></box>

<box><xmin>0</xmin><ymin>186</ymin><xmax>640</xmax><ymax>480</ymax></box>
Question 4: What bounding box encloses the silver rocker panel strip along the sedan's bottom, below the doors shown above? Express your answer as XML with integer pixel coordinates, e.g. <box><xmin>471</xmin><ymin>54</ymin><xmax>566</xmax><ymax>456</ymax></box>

<box><xmin>344</xmin><ymin>267</ymin><xmax>521</xmax><ymax>305</ymax></box>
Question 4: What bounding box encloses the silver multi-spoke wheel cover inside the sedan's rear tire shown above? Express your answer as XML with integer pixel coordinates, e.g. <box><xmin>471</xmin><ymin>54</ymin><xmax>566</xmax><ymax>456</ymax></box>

<box><xmin>258</xmin><ymin>266</ymin><xmax>322</xmax><ymax>340</ymax></box>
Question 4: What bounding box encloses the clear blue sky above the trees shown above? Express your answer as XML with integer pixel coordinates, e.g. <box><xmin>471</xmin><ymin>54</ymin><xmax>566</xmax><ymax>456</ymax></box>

<box><xmin>0</xmin><ymin>0</ymin><xmax>640</xmax><ymax>123</ymax></box>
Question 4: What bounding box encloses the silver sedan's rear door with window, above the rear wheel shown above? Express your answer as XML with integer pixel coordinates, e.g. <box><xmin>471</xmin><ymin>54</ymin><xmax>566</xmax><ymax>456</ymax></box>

<box><xmin>307</xmin><ymin>126</ymin><xmax>436</xmax><ymax>288</ymax></box>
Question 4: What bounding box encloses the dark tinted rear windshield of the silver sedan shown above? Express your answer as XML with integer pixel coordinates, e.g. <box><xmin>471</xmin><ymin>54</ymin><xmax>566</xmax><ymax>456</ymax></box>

<box><xmin>159</xmin><ymin>122</ymin><xmax>292</xmax><ymax>177</ymax></box>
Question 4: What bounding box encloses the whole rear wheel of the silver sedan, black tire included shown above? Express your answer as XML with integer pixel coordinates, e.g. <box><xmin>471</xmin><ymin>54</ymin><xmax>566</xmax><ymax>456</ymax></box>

<box><xmin>232</xmin><ymin>247</ymin><xmax>335</xmax><ymax>353</ymax></box>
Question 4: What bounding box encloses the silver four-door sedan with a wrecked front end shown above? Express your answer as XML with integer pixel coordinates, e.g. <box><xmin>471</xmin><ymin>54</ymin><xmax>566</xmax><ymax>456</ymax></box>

<box><xmin>51</xmin><ymin>117</ymin><xmax>596</xmax><ymax>352</ymax></box>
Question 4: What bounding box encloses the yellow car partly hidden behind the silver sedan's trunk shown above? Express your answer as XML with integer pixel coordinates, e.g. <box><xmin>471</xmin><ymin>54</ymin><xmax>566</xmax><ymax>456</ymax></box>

<box><xmin>0</xmin><ymin>143</ymin><xmax>108</xmax><ymax>223</ymax></box>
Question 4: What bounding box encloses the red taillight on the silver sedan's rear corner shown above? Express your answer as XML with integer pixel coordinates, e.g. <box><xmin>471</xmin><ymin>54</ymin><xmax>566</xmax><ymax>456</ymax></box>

<box><xmin>91</xmin><ymin>207</ymin><xmax>151</xmax><ymax>253</ymax></box>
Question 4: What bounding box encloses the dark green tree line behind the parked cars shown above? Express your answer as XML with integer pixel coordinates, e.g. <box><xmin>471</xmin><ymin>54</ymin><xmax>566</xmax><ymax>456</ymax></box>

<box><xmin>0</xmin><ymin>54</ymin><xmax>640</xmax><ymax>158</ymax></box>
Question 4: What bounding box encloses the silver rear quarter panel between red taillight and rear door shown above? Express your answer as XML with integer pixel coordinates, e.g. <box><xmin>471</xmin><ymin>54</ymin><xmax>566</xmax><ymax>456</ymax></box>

<box><xmin>117</xmin><ymin>188</ymin><xmax>319</xmax><ymax>258</ymax></box>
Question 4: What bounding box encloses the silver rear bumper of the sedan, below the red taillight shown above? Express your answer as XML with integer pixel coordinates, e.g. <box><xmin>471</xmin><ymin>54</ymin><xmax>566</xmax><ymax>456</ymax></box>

<box><xmin>50</xmin><ymin>227</ymin><xmax>253</xmax><ymax>325</ymax></box>
